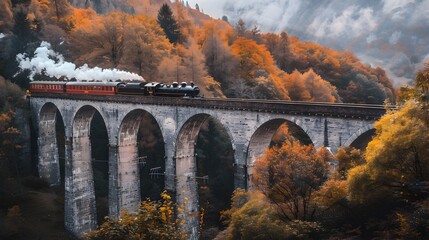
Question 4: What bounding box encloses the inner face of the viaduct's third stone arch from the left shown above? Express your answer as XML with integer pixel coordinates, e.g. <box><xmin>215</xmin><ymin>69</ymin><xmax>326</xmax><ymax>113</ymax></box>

<box><xmin>118</xmin><ymin>109</ymin><xmax>164</xmax><ymax>211</ymax></box>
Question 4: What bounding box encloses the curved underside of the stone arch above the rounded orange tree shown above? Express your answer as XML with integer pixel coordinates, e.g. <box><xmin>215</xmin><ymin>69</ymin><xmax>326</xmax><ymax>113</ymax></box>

<box><xmin>246</xmin><ymin>118</ymin><xmax>313</xmax><ymax>189</ymax></box>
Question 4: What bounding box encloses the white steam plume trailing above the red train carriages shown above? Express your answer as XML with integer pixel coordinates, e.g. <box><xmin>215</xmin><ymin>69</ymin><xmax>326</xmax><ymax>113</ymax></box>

<box><xmin>16</xmin><ymin>42</ymin><xmax>144</xmax><ymax>81</ymax></box>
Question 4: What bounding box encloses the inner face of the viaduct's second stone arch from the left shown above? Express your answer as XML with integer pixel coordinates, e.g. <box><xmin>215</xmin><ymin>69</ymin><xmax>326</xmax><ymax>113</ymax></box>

<box><xmin>65</xmin><ymin>105</ymin><xmax>106</xmax><ymax>233</ymax></box>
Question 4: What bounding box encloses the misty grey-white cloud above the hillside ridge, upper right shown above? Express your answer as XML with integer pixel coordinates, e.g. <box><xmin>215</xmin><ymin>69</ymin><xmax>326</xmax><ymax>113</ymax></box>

<box><xmin>188</xmin><ymin>0</ymin><xmax>429</xmax><ymax>86</ymax></box>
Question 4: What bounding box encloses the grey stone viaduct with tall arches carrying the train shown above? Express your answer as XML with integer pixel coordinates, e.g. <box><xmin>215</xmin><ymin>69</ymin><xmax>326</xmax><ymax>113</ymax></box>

<box><xmin>30</xmin><ymin>94</ymin><xmax>385</xmax><ymax>236</ymax></box>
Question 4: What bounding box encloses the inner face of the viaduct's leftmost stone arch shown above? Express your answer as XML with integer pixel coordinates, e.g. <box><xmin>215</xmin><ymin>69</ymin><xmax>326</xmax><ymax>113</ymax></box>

<box><xmin>37</xmin><ymin>102</ymin><xmax>64</xmax><ymax>186</ymax></box>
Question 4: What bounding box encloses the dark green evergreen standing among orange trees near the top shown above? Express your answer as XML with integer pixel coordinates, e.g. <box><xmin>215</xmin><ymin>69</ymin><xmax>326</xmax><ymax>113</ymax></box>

<box><xmin>157</xmin><ymin>3</ymin><xmax>180</xmax><ymax>43</ymax></box>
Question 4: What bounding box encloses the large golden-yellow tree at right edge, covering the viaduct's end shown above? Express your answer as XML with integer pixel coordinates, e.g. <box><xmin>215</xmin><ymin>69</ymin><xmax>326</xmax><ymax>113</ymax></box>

<box><xmin>348</xmin><ymin>100</ymin><xmax>429</xmax><ymax>203</ymax></box>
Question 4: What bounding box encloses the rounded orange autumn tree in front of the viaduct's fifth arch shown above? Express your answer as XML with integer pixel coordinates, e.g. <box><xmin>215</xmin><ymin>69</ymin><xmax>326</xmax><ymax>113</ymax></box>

<box><xmin>253</xmin><ymin>141</ymin><xmax>327</xmax><ymax>221</ymax></box>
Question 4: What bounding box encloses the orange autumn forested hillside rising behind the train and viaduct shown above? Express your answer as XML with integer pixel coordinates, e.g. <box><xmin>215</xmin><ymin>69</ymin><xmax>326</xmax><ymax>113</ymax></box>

<box><xmin>0</xmin><ymin>0</ymin><xmax>395</xmax><ymax>104</ymax></box>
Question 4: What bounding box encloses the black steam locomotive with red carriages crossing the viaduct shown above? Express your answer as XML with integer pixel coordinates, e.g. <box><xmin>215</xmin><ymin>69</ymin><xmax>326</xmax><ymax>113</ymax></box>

<box><xmin>28</xmin><ymin>81</ymin><xmax>200</xmax><ymax>98</ymax></box>
